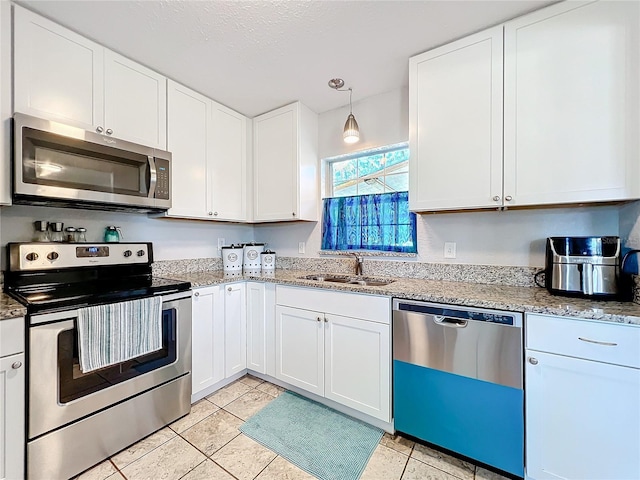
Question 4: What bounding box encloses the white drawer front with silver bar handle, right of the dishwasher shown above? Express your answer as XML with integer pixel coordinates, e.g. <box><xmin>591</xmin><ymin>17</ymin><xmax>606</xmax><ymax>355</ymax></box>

<box><xmin>525</xmin><ymin>314</ymin><xmax>640</xmax><ymax>368</ymax></box>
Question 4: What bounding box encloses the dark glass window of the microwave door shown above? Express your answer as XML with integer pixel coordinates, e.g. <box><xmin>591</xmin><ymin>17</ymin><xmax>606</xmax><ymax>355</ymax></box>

<box><xmin>22</xmin><ymin>128</ymin><xmax>149</xmax><ymax>196</ymax></box>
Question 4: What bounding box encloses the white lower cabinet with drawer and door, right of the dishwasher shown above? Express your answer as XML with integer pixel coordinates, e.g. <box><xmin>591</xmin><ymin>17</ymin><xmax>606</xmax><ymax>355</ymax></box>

<box><xmin>525</xmin><ymin>315</ymin><xmax>640</xmax><ymax>480</ymax></box>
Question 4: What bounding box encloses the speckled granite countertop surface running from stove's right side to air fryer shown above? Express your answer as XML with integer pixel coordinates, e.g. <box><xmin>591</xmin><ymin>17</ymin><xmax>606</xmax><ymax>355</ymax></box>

<box><xmin>163</xmin><ymin>270</ymin><xmax>640</xmax><ymax>325</ymax></box>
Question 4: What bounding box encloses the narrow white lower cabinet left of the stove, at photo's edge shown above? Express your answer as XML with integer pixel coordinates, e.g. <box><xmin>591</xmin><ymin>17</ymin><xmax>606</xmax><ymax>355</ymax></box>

<box><xmin>0</xmin><ymin>318</ymin><xmax>25</xmax><ymax>480</ymax></box>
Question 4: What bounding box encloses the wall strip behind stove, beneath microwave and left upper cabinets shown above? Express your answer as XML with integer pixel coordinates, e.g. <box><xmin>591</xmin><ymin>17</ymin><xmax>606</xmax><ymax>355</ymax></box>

<box><xmin>0</xmin><ymin>205</ymin><xmax>253</xmax><ymax>266</ymax></box>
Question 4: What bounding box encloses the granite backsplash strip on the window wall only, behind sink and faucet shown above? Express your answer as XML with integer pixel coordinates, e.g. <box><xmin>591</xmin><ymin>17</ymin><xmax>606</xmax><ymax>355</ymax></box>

<box><xmin>276</xmin><ymin>257</ymin><xmax>541</xmax><ymax>287</ymax></box>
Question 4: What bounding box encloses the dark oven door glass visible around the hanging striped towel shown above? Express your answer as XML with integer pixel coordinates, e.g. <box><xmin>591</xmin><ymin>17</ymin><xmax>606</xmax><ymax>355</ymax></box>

<box><xmin>58</xmin><ymin>308</ymin><xmax>177</xmax><ymax>403</ymax></box>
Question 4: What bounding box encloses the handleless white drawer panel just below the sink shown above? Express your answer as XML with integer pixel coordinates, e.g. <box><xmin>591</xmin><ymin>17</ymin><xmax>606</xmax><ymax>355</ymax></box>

<box><xmin>276</xmin><ymin>285</ymin><xmax>391</xmax><ymax>325</ymax></box>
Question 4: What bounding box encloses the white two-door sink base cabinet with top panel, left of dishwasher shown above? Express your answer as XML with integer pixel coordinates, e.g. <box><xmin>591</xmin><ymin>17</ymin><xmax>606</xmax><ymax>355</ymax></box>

<box><xmin>275</xmin><ymin>285</ymin><xmax>391</xmax><ymax>422</ymax></box>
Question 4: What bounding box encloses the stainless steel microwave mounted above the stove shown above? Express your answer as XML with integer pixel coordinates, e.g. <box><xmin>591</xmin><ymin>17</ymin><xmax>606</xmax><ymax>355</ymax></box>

<box><xmin>13</xmin><ymin>113</ymin><xmax>171</xmax><ymax>211</ymax></box>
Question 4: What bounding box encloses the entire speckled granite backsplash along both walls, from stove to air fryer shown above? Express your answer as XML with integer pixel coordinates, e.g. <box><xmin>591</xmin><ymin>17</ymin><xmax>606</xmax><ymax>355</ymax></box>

<box><xmin>153</xmin><ymin>257</ymin><xmax>540</xmax><ymax>287</ymax></box>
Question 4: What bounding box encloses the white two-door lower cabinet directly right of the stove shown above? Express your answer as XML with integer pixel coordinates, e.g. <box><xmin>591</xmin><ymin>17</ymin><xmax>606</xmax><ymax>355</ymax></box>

<box><xmin>191</xmin><ymin>283</ymin><xmax>247</xmax><ymax>401</ymax></box>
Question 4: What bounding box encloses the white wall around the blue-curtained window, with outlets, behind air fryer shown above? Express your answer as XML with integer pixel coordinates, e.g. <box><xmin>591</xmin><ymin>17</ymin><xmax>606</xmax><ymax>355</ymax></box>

<box><xmin>254</xmin><ymin>88</ymin><xmax>620</xmax><ymax>266</ymax></box>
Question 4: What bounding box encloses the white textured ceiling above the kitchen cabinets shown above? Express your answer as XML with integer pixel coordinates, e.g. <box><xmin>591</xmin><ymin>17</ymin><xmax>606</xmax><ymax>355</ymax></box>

<box><xmin>18</xmin><ymin>0</ymin><xmax>553</xmax><ymax>117</ymax></box>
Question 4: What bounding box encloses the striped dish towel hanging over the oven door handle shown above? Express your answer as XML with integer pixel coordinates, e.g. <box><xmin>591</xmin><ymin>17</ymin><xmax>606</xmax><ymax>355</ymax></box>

<box><xmin>78</xmin><ymin>296</ymin><xmax>162</xmax><ymax>373</ymax></box>
